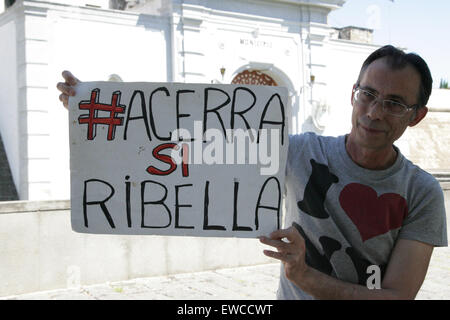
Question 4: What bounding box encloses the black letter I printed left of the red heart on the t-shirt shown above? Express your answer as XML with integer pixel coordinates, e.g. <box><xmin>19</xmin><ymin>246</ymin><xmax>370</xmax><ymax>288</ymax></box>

<box><xmin>297</xmin><ymin>159</ymin><xmax>339</xmax><ymax>219</ymax></box>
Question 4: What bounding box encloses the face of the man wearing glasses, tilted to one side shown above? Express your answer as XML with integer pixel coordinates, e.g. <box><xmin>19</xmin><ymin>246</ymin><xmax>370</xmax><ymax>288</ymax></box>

<box><xmin>350</xmin><ymin>58</ymin><xmax>426</xmax><ymax>151</ymax></box>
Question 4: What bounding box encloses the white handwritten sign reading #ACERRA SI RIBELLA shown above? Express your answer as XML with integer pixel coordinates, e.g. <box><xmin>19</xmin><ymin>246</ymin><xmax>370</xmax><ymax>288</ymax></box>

<box><xmin>69</xmin><ymin>82</ymin><xmax>288</xmax><ymax>237</ymax></box>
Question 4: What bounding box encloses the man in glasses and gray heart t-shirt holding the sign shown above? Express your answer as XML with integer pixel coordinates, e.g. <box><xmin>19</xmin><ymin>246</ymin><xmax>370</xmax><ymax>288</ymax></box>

<box><xmin>57</xmin><ymin>46</ymin><xmax>447</xmax><ymax>299</ymax></box>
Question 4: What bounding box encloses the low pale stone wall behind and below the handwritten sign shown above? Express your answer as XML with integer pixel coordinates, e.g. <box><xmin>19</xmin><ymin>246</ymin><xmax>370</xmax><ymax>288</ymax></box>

<box><xmin>0</xmin><ymin>200</ymin><xmax>273</xmax><ymax>297</ymax></box>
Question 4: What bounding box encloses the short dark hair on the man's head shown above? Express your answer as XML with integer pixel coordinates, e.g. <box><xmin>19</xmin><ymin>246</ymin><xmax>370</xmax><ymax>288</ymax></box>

<box><xmin>356</xmin><ymin>45</ymin><xmax>433</xmax><ymax>108</ymax></box>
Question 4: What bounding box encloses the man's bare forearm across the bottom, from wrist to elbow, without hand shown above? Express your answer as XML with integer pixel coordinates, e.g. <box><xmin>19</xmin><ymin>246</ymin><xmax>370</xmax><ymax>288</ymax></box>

<box><xmin>293</xmin><ymin>267</ymin><xmax>406</xmax><ymax>300</ymax></box>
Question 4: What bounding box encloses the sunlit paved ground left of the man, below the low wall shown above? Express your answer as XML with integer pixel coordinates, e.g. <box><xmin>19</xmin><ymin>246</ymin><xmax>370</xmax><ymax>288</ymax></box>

<box><xmin>0</xmin><ymin>264</ymin><xmax>279</xmax><ymax>300</ymax></box>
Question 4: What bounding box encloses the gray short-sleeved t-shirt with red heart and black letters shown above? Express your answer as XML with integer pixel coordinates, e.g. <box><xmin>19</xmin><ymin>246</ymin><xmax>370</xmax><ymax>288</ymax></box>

<box><xmin>277</xmin><ymin>133</ymin><xmax>447</xmax><ymax>299</ymax></box>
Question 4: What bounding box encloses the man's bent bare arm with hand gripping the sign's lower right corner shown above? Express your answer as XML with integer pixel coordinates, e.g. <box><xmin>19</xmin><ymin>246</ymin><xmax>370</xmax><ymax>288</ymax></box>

<box><xmin>260</xmin><ymin>227</ymin><xmax>433</xmax><ymax>300</ymax></box>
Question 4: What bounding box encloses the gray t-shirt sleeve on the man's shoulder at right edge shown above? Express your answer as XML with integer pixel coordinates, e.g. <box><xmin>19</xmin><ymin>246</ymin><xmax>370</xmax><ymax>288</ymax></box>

<box><xmin>399</xmin><ymin>176</ymin><xmax>448</xmax><ymax>247</ymax></box>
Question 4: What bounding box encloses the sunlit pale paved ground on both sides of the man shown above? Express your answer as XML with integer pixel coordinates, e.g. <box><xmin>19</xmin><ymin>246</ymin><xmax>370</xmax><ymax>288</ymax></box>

<box><xmin>0</xmin><ymin>247</ymin><xmax>450</xmax><ymax>300</ymax></box>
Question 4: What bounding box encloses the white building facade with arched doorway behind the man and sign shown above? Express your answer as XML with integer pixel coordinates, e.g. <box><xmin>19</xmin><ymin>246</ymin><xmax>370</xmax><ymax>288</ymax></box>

<box><xmin>0</xmin><ymin>0</ymin><xmax>442</xmax><ymax>200</ymax></box>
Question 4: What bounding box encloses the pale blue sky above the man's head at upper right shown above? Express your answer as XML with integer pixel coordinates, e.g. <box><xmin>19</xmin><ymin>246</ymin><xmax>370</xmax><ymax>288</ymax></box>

<box><xmin>328</xmin><ymin>0</ymin><xmax>450</xmax><ymax>88</ymax></box>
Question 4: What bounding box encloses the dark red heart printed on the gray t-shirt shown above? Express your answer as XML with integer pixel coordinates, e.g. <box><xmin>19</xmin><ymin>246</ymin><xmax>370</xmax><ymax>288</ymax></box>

<box><xmin>339</xmin><ymin>183</ymin><xmax>408</xmax><ymax>242</ymax></box>
